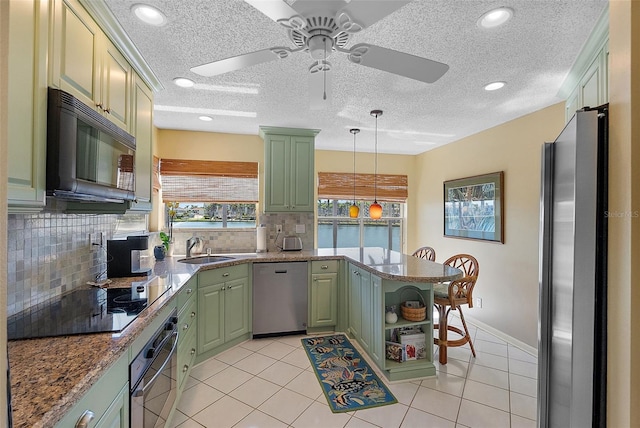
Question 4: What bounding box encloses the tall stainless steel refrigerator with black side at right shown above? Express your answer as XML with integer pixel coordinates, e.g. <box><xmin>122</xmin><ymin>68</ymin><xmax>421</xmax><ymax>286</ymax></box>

<box><xmin>538</xmin><ymin>105</ymin><xmax>609</xmax><ymax>428</ymax></box>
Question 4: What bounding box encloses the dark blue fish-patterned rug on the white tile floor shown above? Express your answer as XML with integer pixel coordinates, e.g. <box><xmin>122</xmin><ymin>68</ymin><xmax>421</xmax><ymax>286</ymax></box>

<box><xmin>302</xmin><ymin>334</ymin><xmax>398</xmax><ymax>413</ymax></box>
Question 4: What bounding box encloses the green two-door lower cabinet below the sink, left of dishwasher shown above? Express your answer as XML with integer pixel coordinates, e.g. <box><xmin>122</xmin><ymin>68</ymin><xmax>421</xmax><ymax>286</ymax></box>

<box><xmin>197</xmin><ymin>271</ymin><xmax>251</xmax><ymax>355</ymax></box>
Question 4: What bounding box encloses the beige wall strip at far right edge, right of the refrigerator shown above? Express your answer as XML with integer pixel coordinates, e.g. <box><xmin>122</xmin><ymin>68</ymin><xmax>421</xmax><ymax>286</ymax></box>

<box><xmin>607</xmin><ymin>0</ymin><xmax>640</xmax><ymax>428</ymax></box>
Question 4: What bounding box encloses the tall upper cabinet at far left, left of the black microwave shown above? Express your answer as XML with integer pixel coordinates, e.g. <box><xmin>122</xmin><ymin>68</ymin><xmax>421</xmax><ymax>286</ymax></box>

<box><xmin>7</xmin><ymin>0</ymin><xmax>49</xmax><ymax>213</ymax></box>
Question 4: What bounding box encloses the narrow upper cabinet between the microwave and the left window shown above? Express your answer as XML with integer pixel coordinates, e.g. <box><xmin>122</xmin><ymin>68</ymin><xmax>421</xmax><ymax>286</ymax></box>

<box><xmin>131</xmin><ymin>75</ymin><xmax>153</xmax><ymax>211</ymax></box>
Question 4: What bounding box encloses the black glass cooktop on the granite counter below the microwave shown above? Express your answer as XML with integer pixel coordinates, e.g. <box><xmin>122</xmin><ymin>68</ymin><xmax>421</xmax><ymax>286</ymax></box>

<box><xmin>7</xmin><ymin>282</ymin><xmax>168</xmax><ymax>340</ymax></box>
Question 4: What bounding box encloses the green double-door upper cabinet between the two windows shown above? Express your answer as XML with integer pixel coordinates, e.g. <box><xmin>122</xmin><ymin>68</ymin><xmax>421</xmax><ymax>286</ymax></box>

<box><xmin>260</xmin><ymin>126</ymin><xmax>320</xmax><ymax>212</ymax></box>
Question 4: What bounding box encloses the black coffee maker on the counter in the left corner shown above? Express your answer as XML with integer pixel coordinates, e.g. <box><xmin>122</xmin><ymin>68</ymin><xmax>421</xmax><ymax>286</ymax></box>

<box><xmin>107</xmin><ymin>235</ymin><xmax>151</xmax><ymax>278</ymax></box>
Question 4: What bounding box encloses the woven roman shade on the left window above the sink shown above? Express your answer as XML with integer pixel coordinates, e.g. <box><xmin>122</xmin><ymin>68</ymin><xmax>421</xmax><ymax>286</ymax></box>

<box><xmin>160</xmin><ymin>159</ymin><xmax>259</xmax><ymax>203</ymax></box>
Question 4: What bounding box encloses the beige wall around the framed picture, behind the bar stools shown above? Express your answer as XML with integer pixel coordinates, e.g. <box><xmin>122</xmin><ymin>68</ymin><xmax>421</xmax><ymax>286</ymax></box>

<box><xmin>409</xmin><ymin>103</ymin><xmax>564</xmax><ymax>348</ymax></box>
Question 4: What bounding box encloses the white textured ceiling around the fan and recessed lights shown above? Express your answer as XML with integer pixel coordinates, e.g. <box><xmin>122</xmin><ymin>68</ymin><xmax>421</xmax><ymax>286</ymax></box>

<box><xmin>106</xmin><ymin>0</ymin><xmax>607</xmax><ymax>154</ymax></box>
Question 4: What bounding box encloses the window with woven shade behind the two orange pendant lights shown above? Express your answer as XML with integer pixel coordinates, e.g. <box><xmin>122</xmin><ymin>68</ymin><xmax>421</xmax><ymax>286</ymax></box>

<box><xmin>318</xmin><ymin>172</ymin><xmax>408</xmax><ymax>251</ymax></box>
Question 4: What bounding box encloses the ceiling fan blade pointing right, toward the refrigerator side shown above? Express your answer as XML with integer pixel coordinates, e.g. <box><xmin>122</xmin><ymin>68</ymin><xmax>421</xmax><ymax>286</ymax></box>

<box><xmin>348</xmin><ymin>43</ymin><xmax>449</xmax><ymax>83</ymax></box>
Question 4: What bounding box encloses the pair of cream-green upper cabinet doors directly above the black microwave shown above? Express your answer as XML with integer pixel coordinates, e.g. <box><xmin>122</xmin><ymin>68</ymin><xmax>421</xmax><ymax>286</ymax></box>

<box><xmin>49</xmin><ymin>0</ymin><xmax>133</xmax><ymax>132</ymax></box>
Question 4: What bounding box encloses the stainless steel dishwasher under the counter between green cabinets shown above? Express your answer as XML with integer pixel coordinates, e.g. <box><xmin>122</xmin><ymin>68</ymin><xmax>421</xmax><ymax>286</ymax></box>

<box><xmin>253</xmin><ymin>262</ymin><xmax>308</xmax><ymax>337</ymax></box>
